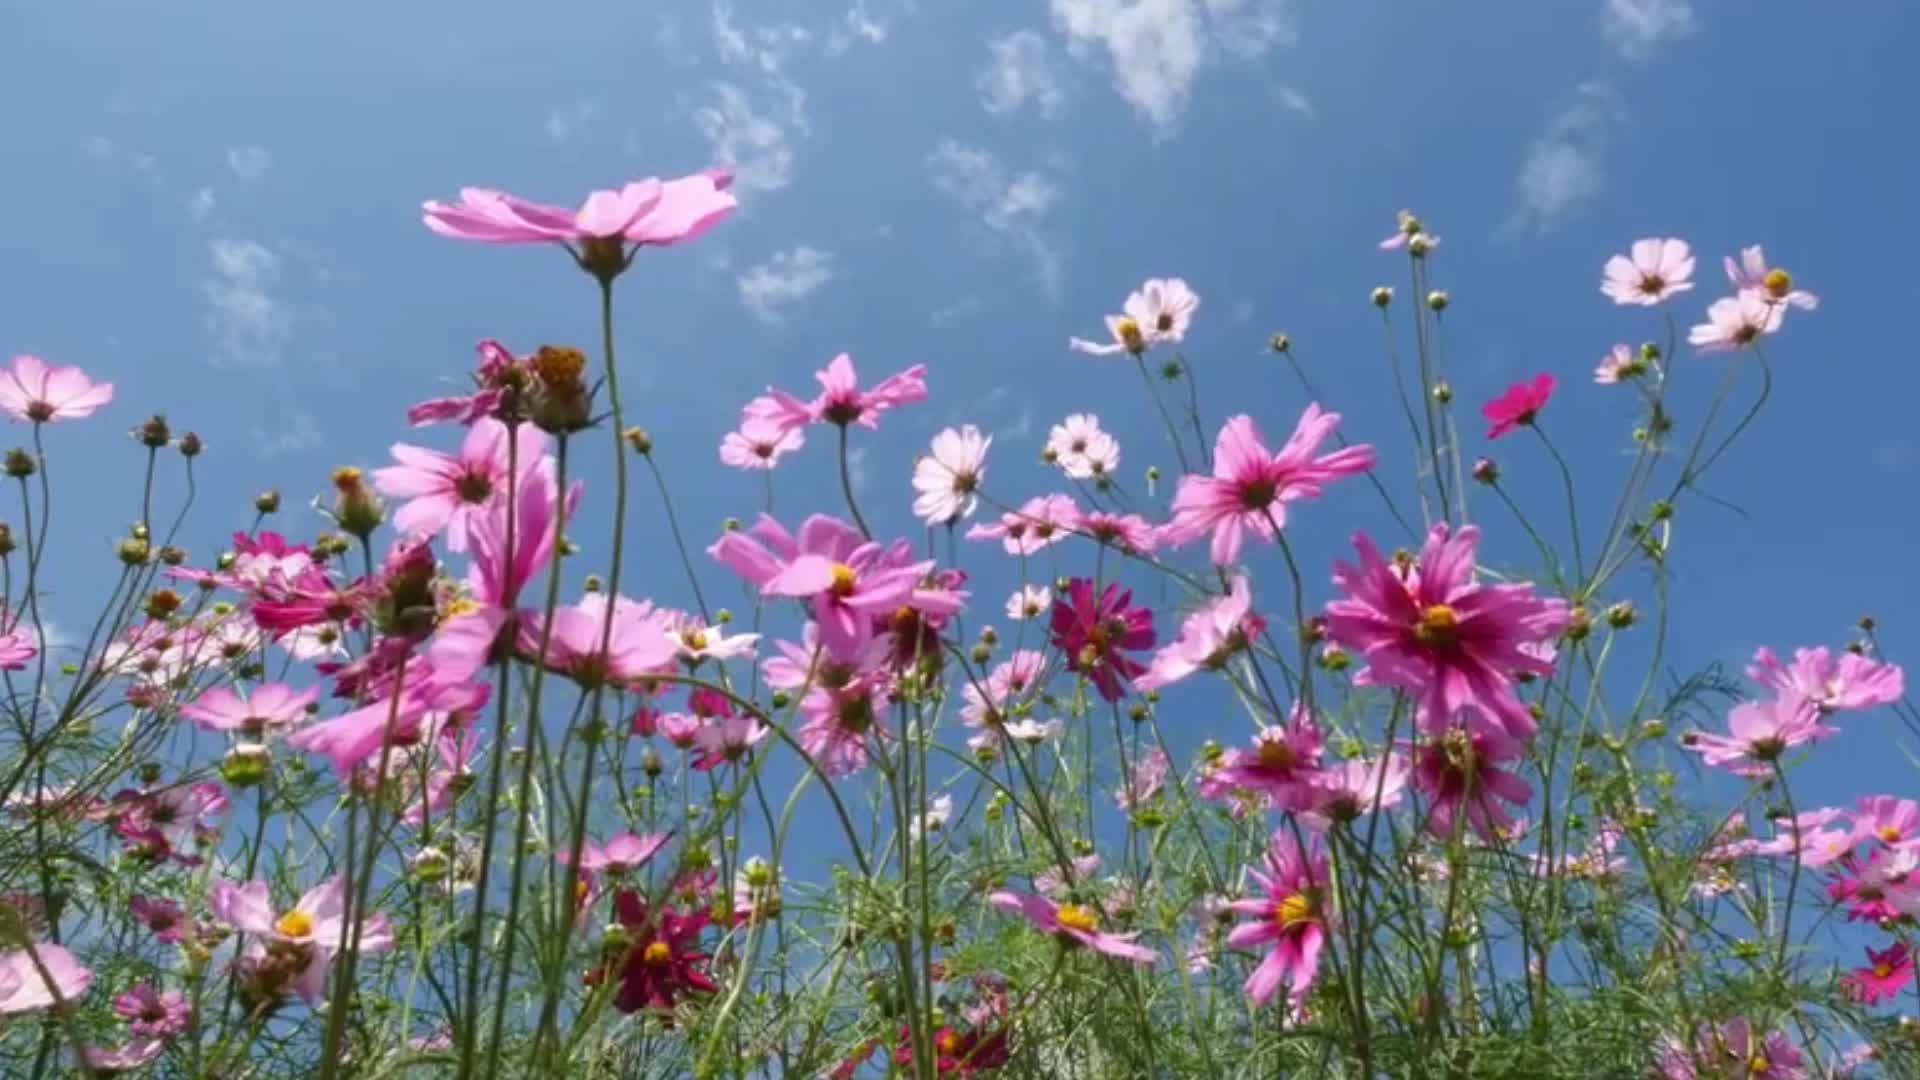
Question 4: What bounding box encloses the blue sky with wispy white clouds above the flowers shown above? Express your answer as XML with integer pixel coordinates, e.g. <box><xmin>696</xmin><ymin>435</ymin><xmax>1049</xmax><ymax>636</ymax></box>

<box><xmin>0</xmin><ymin>0</ymin><xmax>1920</xmax><ymax>803</ymax></box>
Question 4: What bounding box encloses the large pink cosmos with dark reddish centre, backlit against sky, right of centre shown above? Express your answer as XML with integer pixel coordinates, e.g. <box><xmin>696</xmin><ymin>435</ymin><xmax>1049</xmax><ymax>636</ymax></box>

<box><xmin>1164</xmin><ymin>404</ymin><xmax>1373</xmax><ymax>565</ymax></box>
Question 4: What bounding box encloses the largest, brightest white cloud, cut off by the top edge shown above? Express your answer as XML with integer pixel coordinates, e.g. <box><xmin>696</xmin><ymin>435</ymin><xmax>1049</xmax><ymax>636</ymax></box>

<box><xmin>1050</xmin><ymin>0</ymin><xmax>1298</xmax><ymax>135</ymax></box>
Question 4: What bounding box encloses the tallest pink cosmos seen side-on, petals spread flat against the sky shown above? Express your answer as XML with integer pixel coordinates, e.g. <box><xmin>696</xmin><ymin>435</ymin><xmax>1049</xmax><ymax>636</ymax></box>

<box><xmin>422</xmin><ymin>169</ymin><xmax>739</xmax><ymax>246</ymax></box>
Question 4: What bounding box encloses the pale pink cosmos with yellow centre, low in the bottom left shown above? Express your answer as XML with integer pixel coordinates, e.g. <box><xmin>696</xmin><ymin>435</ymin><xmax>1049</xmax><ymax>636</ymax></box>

<box><xmin>211</xmin><ymin>874</ymin><xmax>394</xmax><ymax>1005</ymax></box>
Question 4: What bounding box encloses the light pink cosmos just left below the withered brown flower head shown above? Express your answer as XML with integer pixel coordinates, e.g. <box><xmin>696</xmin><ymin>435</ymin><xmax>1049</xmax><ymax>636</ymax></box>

<box><xmin>372</xmin><ymin>417</ymin><xmax>547</xmax><ymax>552</ymax></box>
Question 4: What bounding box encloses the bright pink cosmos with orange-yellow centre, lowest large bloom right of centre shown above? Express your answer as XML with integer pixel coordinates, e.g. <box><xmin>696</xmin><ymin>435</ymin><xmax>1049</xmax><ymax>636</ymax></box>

<box><xmin>1227</xmin><ymin>828</ymin><xmax>1332</xmax><ymax>1017</ymax></box>
